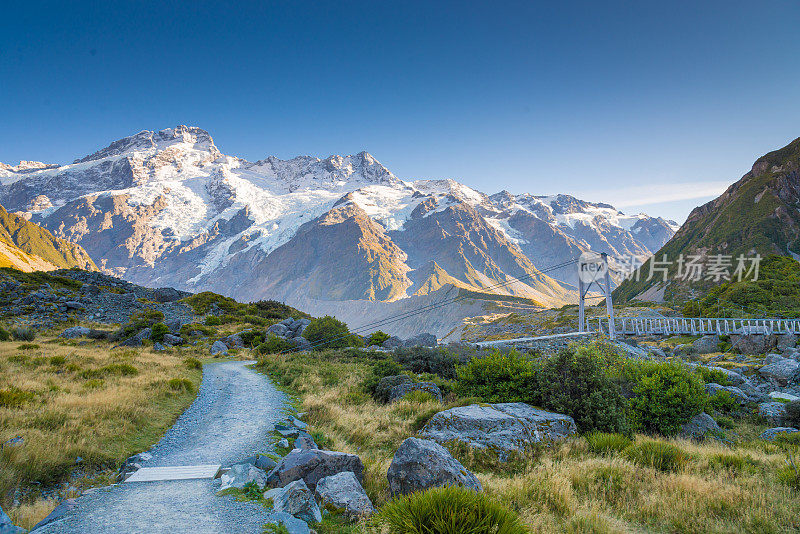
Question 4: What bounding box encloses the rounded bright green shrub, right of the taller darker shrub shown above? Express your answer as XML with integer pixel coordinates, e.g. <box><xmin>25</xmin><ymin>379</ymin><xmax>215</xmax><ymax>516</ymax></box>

<box><xmin>625</xmin><ymin>361</ymin><xmax>708</xmax><ymax>436</ymax></box>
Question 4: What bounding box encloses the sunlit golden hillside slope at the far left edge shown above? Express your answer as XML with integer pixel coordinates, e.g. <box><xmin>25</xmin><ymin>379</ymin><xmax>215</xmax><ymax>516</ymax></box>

<box><xmin>0</xmin><ymin>206</ymin><xmax>97</xmax><ymax>271</ymax></box>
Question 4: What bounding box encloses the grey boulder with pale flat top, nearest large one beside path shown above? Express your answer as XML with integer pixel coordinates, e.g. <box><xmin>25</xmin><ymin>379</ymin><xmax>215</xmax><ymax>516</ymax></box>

<box><xmin>267</xmin><ymin>449</ymin><xmax>364</xmax><ymax>490</ymax></box>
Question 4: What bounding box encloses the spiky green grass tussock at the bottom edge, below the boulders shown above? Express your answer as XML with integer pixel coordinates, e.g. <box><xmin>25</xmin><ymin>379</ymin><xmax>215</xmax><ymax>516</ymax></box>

<box><xmin>376</xmin><ymin>486</ymin><xmax>528</xmax><ymax>534</ymax></box>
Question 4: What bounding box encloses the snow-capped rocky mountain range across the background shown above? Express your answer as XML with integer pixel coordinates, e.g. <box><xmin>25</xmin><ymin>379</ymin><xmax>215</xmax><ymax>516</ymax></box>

<box><xmin>0</xmin><ymin>126</ymin><xmax>674</xmax><ymax>336</ymax></box>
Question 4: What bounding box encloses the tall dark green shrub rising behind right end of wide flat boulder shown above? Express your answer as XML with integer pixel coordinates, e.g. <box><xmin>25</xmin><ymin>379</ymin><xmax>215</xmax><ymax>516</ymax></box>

<box><xmin>526</xmin><ymin>345</ymin><xmax>629</xmax><ymax>434</ymax></box>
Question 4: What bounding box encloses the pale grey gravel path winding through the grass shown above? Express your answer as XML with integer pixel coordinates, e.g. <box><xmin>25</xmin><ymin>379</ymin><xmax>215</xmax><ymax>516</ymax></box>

<box><xmin>33</xmin><ymin>361</ymin><xmax>286</xmax><ymax>534</ymax></box>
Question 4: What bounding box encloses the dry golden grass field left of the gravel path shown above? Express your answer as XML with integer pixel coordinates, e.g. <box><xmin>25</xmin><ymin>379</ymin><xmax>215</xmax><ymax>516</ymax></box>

<box><xmin>0</xmin><ymin>338</ymin><xmax>201</xmax><ymax>528</ymax></box>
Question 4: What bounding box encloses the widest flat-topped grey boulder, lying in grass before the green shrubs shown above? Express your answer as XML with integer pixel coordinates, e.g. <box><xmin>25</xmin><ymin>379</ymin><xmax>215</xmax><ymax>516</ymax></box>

<box><xmin>421</xmin><ymin>402</ymin><xmax>577</xmax><ymax>455</ymax></box>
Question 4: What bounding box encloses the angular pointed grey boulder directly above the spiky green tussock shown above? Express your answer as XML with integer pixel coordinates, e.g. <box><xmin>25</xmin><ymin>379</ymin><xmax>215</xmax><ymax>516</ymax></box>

<box><xmin>386</xmin><ymin>438</ymin><xmax>483</xmax><ymax>496</ymax></box>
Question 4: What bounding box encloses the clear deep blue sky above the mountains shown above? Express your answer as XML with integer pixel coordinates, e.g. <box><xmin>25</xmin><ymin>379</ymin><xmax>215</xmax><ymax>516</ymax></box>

<box><xmin>0</xmin><ymin>0</ymin><xmax>800</xmax><ymax>222</ymax></box>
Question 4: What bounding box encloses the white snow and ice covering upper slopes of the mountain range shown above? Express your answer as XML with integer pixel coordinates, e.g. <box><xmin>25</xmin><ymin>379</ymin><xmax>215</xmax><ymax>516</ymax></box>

<box><xmin>0</xmin><ymin>126</ymin><xmax>674</xmax><ymax>302</ymax></box>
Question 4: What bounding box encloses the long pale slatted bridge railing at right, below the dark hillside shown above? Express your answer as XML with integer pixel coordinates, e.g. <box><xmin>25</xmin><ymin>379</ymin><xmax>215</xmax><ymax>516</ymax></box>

<box><xmin>589</xmin><ymin>317</ymin><xmax>800</xmax><ymax>335</ymax></box>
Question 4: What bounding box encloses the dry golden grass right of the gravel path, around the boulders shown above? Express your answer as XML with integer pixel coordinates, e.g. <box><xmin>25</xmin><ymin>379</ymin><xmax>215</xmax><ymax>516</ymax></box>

<box><xmin>260</xmin><ymin>353</ymin><xmax>800</xmax><ymax>533</ymax></box>
